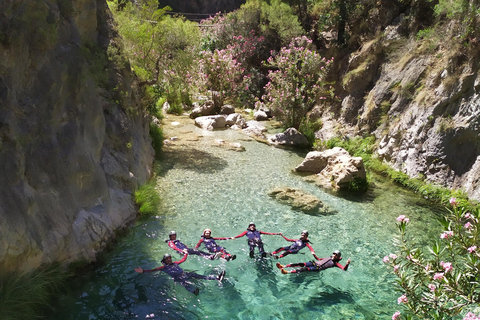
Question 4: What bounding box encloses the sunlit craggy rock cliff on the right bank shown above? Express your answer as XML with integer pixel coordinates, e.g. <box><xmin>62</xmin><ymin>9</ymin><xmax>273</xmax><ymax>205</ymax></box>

<box><xmin>316</xmin><ymin>15</ymin><xmax>480</xmax><ymax>200</ymax></box>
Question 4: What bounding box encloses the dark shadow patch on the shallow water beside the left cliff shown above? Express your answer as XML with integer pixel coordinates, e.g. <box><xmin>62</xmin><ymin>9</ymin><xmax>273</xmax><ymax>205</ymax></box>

<box><xmin>158</xmin><ymin>148</ymin><xmax>228</xmax><ymax>177</ymax></box>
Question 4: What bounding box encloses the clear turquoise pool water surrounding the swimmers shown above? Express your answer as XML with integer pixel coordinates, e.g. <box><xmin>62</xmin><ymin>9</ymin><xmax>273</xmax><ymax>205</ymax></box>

<box><xmin>50</xmin><ymin>118</ymin><xmax>440</xmax><ymax>319</ymax></box>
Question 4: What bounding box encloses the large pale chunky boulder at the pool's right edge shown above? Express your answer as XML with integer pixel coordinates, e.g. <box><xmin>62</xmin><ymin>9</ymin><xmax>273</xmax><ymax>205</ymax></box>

<box><xmin>295</xmin><ymin>147</ymin><xmax>367</xmax><ymax>190</ymax></box>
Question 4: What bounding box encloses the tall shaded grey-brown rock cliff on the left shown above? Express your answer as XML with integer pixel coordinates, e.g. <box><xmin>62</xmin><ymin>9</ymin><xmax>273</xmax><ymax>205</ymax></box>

<box><xmin>0</xmin><ymin>0</ymin><xmax>153</xmax><ymax>271</ymax></box>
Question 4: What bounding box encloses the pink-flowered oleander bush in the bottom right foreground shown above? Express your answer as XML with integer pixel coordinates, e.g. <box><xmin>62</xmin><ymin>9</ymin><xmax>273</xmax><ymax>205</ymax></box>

<box><xmin>383</xmin><ymin>198</ymin><xmax>480</xmax><ymax>319</ymax></box>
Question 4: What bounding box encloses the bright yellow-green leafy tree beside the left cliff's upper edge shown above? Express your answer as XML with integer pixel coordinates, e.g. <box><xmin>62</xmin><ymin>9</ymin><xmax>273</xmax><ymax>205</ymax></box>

<box><xmin>108</xmin><ymin>0</ymin><xmax>200</xmax><ymax>110</ymax></box>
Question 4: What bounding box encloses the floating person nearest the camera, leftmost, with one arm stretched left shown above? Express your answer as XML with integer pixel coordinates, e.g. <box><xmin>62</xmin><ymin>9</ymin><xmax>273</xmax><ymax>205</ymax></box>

<box><xmin>135</xmin><ymin>253</ymin><xmax>225</xmax><ymax>295</ymax></box>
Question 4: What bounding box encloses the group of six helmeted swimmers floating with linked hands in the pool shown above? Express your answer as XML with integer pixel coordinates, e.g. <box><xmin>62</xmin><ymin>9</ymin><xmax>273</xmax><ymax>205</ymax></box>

<box><xmin>135</xmin><ymin>222</ymin><xmax>350</xmax><ymax>295</ymax></box>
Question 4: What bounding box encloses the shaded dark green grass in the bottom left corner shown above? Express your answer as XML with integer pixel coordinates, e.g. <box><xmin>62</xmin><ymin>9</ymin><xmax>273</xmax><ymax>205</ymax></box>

<box><xmin>0</xmin><ymin>266</ymin><xmax>67</xmax><ymax>320</ymax></box>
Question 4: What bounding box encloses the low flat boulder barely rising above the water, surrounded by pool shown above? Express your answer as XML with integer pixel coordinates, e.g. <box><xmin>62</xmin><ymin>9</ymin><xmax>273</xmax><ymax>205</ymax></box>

<box><xmin>268</xmin><ymin>187</ymin><xmax>329</xmax><ymax>214</ymax></box>
